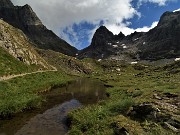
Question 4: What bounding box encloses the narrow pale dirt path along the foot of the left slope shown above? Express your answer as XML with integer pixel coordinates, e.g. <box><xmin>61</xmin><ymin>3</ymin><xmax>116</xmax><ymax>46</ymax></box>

<box><xmin>0</xmin><ymin>69</ymin><xmax>57</xmax><ymax>81</ymax></box>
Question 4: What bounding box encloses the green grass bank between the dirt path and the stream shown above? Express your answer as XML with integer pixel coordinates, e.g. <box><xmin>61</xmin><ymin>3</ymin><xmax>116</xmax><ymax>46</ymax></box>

<box><xmin>0</xmin><ymin>72</ymin><xmax>73</xmax><ymax>116</ymax></box>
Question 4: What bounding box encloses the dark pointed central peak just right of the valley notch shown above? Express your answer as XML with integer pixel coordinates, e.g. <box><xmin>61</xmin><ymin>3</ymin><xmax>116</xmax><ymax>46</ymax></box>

<box><xmin>78</xmin><ymin>26</ymin><xmax>125</xmax><ymax>59</ymax></box>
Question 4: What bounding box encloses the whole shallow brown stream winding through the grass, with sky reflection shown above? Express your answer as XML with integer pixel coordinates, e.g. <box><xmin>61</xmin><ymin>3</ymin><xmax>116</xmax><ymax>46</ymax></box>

<box><xmin>0</xmin><ymin>78</ymin><xmax>106</xmax><ymax>135</ymax></box>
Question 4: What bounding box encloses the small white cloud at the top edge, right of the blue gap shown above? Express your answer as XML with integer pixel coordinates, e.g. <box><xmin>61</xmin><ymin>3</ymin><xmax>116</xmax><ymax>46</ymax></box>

<box><xmin>139</xmin><ymin>0</ymin><xmax>177</xmax><ymax>6</ymax></box>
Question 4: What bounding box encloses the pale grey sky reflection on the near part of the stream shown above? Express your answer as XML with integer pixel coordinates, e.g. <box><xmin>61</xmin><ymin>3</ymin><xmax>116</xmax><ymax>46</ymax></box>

<box><xmin>15</xmin><ymin>99</ymin><xmax>81</xmax><ymax>135</ymax></box>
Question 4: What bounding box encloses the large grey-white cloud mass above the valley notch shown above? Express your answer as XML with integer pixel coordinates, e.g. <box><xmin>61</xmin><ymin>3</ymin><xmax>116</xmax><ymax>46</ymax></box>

<box><xmin>12</xmin><ymin>0</ymin><xmax>140</xmax><ymax>48</ymax></box>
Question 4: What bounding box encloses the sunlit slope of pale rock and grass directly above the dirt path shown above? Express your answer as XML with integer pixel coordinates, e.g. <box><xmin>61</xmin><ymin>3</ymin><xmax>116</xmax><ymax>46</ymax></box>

<box><xmin>0</xmin><ymin>20</ymin><xmax>52</xmax><ymax>75</ymax></box>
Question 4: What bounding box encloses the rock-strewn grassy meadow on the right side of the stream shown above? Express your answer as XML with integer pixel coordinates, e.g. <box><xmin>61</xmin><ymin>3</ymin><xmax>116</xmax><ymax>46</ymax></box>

<box><xmin>68</xmin><ymin>61</ymin><xmax>180</xmax><ymax>135</ymax></box>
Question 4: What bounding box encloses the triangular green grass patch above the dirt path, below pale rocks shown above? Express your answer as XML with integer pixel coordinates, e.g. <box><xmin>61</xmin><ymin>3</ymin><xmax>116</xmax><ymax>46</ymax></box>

<box><xmin>0</xmin><ymin>47</ymin><xmax>37</xmax><ymax>76</ymax></box>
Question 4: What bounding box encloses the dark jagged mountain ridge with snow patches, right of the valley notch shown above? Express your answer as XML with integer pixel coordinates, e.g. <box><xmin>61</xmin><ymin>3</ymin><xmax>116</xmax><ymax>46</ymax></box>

<box><xmin>79</xmin><ymin>12</ymin><xmax>180</xmax><ymax>60</ymax></box>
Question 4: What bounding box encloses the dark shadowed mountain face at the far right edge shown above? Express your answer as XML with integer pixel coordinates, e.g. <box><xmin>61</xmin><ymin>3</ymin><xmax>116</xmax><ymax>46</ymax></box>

<box><xmin>139</xmin><ymin>12</ymin><xmax>180</xmax><ymax>59</ymax></box>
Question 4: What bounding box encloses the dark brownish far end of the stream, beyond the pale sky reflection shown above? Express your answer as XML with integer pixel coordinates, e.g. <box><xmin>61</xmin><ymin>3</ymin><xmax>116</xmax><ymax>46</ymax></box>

<box><xmin>57</xmin><ymin>78</ymin><xmax>105</xmax><ymax>104</ymax></box>
